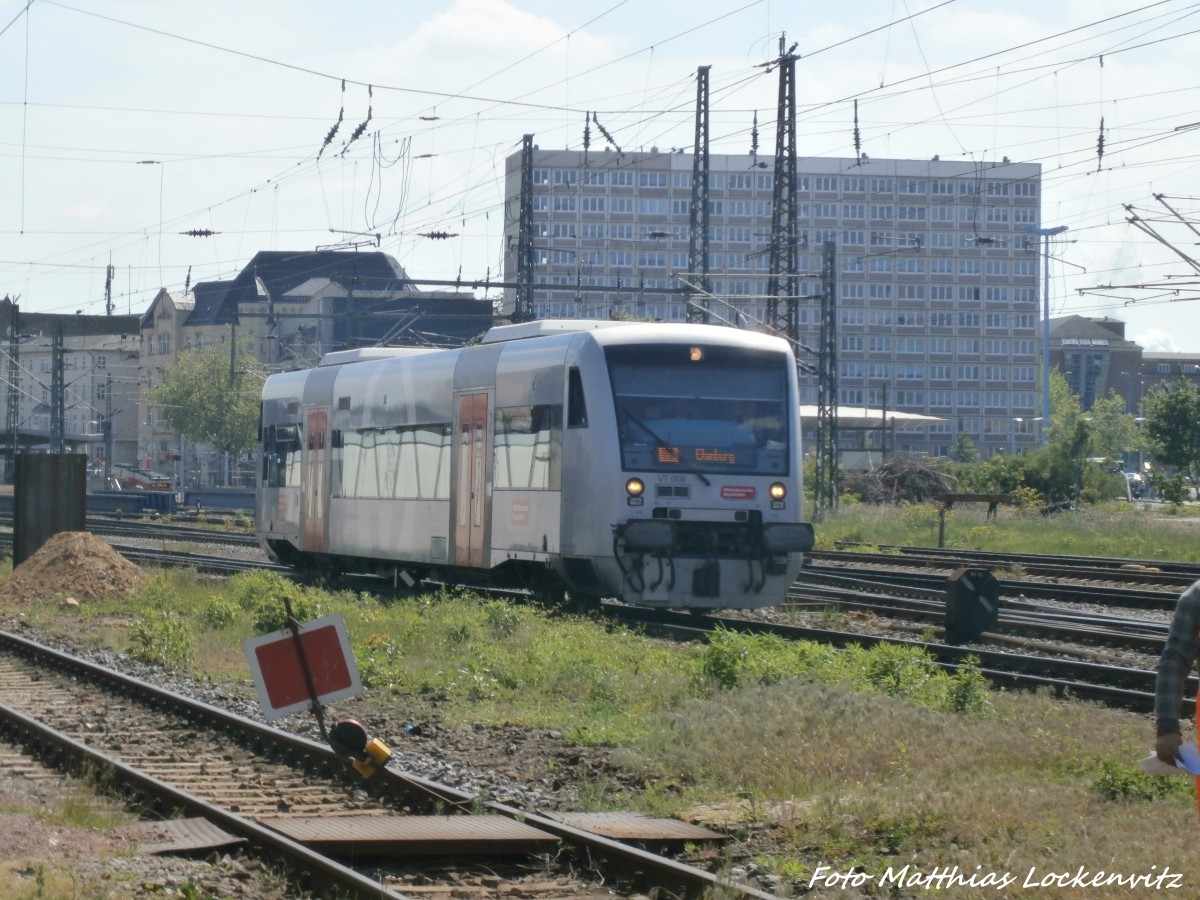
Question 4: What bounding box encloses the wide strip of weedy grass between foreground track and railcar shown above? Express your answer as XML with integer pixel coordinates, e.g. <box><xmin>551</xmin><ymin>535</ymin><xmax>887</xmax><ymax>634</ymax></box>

<box><xmin>9</xmin><ymin>547</ymin><xmax>1200</xmax><ymax>898</ymax></box>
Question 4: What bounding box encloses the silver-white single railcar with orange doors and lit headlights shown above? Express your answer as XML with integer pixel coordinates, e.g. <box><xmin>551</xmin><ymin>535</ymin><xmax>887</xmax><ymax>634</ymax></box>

<box><xmin>256</xmin><ymin>320</ymin><xmax>812</xmax><ymax>608</ymax></box>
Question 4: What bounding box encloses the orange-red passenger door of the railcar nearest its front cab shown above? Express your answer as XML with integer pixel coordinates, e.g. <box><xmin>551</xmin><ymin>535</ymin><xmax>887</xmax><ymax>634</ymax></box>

<box><xmin>454</xmin><ymin>394</ymin><xmax>492</xmax><ymax>566</ymax></box>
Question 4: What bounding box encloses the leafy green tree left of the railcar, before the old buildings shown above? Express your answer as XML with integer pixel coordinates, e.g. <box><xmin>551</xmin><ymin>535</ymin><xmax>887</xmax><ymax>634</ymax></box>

<box><xmin>146</xmin><ymin>343</ymin><xmax>265</xmax><ymax>465</ymax></box>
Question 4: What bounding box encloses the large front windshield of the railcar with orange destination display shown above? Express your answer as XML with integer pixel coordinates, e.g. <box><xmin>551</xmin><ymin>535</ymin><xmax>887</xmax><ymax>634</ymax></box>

<box><xmin>605</xmin><ymin>344</ymin><xmax>793</xmax><ymax>475</ymax></box>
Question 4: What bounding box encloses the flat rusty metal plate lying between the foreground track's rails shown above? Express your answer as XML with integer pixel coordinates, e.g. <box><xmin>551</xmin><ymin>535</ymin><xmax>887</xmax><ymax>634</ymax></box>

<box><xmin>258</xmin><ymin>816</ymin><xmax>558</xmax><ymax>857</ymax></box>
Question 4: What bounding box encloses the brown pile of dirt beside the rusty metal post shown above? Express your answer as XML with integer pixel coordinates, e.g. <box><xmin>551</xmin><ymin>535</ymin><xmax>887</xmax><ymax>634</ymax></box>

<box><xmin>0</xmin><ymin>532</ymin><xmax>148</xmax><ymax>601</ymax></box>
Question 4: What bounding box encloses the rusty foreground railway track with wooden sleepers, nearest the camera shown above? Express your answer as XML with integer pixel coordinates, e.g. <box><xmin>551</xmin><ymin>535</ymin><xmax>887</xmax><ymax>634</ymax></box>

<box><xmin>0</xmin><ymin>634</ymin><xmax>769</xmax><ymax>898</ymax></box>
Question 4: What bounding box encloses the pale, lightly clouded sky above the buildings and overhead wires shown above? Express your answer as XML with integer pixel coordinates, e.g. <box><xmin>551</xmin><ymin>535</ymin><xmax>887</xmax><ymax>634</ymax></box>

<box><xmin>0</xmin><ymin>0</ymin><xmax>1200</xmax><ymax>353</ymax></box>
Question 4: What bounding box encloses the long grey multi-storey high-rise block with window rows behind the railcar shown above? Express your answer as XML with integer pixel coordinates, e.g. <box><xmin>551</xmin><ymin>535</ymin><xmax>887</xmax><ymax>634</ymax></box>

<box><xmin>504</xmin><ymin>148</ymin><xmax>1043</xmax><ymax>456</ymax></box>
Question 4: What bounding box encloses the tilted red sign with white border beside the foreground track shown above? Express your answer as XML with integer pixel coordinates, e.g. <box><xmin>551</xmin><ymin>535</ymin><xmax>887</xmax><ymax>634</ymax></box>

<box><xmin>244</xmin><ymin>614</ymin><xmax>362</xmax><ymax>721</ymax></box>
